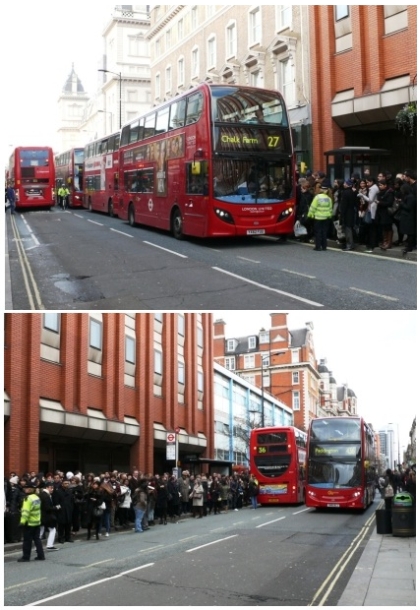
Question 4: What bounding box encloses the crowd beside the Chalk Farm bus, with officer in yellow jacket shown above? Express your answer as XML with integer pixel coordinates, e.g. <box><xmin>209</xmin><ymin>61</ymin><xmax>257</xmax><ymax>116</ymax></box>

<box><xmin>296</xmin><ymin>169</ymin><xmax>417</xmax><ymax>256</ymax></box>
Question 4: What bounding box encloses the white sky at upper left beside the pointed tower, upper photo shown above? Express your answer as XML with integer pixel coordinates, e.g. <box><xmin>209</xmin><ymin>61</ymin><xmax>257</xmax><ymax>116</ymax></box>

<box><xmin>2</xmin><ymin>0</ymin><xmax>116</xmax><ymax>163</ymax></box>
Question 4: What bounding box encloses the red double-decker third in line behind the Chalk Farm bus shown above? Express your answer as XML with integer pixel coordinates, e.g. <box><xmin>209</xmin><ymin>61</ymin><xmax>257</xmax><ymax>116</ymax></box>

<box><xmin>55</xmin><ymin>148</ymin><xmax>85</xmax><ymax>208</ymax></box>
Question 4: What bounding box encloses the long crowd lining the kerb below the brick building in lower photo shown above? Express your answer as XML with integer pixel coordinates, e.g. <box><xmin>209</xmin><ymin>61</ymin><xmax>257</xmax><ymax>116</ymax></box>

<box><xmin>4</xmin><ymin>470</ymin><xmax>258</xmax><ymax>551</ymax></box>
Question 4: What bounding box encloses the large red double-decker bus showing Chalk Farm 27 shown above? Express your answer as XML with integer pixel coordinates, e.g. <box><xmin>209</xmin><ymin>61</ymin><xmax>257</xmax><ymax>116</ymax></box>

<box><xmin>118</xmin><ymin>84</ymin><xmax>295</xmax><ymax>239</ymax></box>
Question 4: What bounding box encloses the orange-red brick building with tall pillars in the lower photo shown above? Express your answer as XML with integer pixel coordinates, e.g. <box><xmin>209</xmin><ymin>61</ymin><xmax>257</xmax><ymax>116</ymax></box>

<box><xmin>4</xmin><ymin>312</ymin><xmax>214</xmax><ymax>472</ymax></box>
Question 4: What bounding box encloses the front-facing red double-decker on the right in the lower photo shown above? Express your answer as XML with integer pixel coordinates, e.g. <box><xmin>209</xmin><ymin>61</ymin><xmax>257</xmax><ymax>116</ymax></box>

<box><xmin>306</xmin><ymin>417</ymin><xmax>375</xmax><ymax>509</ymax></box>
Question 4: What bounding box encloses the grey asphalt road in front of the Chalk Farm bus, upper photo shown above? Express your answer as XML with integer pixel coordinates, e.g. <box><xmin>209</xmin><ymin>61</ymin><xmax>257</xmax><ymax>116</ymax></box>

<box><xmin>7</xmin><ymin>209</ymin><xmax>417</xmax><ymax>310</ymax></box>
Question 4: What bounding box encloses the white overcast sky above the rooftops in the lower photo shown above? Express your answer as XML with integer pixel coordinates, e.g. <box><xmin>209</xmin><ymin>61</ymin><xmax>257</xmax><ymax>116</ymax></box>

<box><xmin>217</xmin><ymin>311</ymin><xmax>418</xmax><ymax>447</ymax></box>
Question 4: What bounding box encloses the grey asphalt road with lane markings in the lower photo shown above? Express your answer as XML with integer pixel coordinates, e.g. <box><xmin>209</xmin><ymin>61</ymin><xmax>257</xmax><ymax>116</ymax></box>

<box><xmin>4</xmin><ymin>502</ymin><xmax>377</xmax><ymax>607</ymax></box>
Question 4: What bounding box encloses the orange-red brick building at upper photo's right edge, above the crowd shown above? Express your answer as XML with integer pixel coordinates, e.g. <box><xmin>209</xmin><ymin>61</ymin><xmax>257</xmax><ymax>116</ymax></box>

<box><xmin>310</xmin><ymin>5</ymin><xmax>417</xmax><ymax>173</ymax></box>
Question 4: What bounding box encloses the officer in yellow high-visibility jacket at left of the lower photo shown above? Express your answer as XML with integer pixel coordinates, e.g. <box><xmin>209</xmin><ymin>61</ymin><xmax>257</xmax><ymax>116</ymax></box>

<box><xmin>18</xmin><ymin>481</ymin><xmax>45</xmax><ymax>562</ymax></box>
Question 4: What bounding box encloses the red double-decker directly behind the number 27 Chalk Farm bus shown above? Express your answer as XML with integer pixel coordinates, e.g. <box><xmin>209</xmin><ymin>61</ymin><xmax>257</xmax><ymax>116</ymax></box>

<box><xmin>84</xmin><ymin>132</ymin><xmax>120</xmax><ymax>216</ymax></box>
